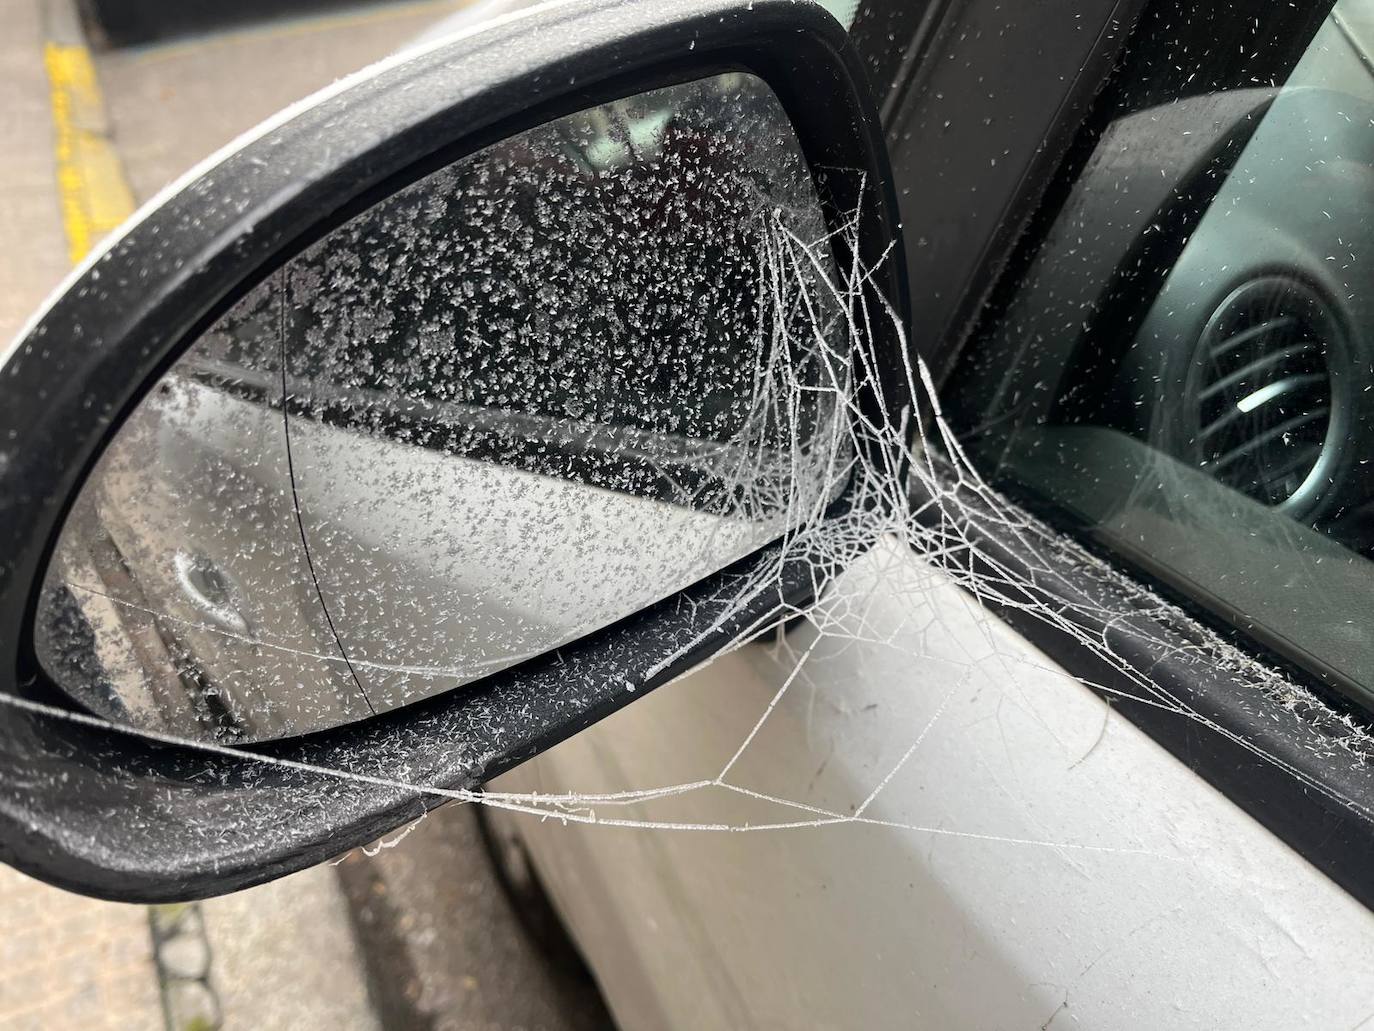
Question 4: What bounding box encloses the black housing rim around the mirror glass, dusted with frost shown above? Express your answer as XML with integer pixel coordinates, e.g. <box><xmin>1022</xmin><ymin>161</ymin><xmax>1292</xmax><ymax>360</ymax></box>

<box><xmin>0</xmin><ymin>0</ymin><xmax>907</xmax><ymax>902</ymax></box>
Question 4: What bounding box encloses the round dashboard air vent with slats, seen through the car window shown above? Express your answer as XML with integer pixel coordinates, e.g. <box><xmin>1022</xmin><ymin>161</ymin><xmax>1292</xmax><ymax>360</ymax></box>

<box><xmin>1189</xmin><ymin>276</ymin><xmax>1341</xmax><ymax>509</ymax></box>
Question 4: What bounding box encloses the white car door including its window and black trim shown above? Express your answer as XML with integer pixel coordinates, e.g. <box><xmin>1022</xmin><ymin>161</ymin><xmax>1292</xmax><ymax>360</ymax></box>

<box><xmin>496</xmin><ymin>0</ymin><xmax>1374</xmax><ymax>1028</ymax></box>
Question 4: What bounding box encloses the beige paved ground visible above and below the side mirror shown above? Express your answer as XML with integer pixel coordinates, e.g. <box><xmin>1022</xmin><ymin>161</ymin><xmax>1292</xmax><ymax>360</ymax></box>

<box><xmin>0</xmin><ymin>0</ymin><xmax>610</xmax><ymax>1031</ymax></box>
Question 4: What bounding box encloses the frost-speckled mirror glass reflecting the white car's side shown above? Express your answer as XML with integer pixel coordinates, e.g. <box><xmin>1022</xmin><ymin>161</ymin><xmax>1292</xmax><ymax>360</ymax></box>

<box><xmin>34</xmin><ymin>73</ymin><xmax>849</xmax><ymax>741</ymax></box>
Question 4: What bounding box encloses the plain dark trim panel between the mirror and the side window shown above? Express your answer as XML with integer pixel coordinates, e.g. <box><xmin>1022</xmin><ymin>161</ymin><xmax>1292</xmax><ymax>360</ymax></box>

<box><xmin>873</xmin><ymin>0</ymin><xmax>1146</xmax><ymax>382</ymax></box>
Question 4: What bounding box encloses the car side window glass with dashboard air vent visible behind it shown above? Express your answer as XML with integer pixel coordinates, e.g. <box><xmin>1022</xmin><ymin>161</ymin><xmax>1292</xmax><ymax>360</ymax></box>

<box><xmin>947</xmin><ymin>0</ymin><xmax>1374</xmax><ymax>702</ymax></box>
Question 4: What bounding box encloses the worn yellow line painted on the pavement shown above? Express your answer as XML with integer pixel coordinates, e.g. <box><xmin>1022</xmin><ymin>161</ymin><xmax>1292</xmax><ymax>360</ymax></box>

<box><xmin>43</xmin><ymin>43</ymin><xmax>133</xmax><ymax>264</ymax></box>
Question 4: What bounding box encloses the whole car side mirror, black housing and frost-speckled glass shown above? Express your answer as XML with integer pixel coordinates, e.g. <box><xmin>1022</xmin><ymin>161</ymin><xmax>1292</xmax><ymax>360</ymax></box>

<box><xmin>0</xmin><ymin>0</ymin><xmax>910</xmax><ymax>900</ymax></box>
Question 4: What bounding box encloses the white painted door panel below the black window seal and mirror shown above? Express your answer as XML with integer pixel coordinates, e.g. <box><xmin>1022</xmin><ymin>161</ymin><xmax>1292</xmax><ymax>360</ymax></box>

<box><xmin>495</xmin><ymin>540</ymin><xmax>1374</xmax><ymax>1031</ymax></box>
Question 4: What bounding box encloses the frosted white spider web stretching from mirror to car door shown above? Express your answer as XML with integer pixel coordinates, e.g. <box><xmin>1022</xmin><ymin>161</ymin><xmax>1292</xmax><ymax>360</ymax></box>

<box><xmin>3</xmin><ymin>155</ymin><xmax>1374</xmax><ymax>874</ymax></box>
